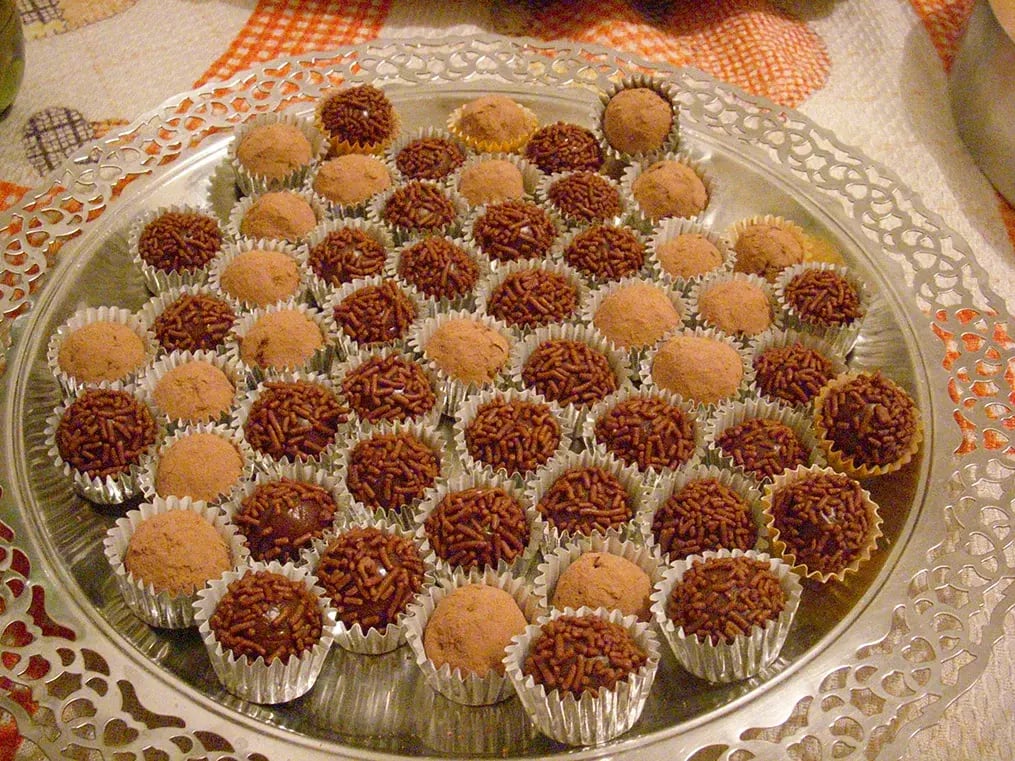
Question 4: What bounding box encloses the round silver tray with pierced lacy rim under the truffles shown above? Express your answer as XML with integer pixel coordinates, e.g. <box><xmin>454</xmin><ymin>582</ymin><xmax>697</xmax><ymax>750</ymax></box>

<box><xmin>0</xmin><ymin>37</ymin><xmax>1015</xmax><ymax>761</ymax></box>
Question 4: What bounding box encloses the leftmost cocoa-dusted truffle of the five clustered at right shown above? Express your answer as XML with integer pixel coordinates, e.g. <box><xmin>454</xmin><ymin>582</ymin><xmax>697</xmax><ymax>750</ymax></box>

<box><xmin>593</xmin><ymin>282</ymin><xmax>680</xmax><ymax>349</ymax></box>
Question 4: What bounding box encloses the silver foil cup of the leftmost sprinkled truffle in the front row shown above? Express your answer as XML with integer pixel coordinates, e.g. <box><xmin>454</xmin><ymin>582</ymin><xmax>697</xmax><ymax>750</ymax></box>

<box><xmin>194</xmin><ymin>563</ymin><xmax>335</xmax><ymax>703</ymax></box>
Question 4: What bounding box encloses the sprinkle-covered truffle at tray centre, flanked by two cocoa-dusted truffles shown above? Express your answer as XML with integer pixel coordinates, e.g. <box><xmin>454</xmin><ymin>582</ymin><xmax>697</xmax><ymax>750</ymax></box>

<box><xmin>522</xmin><ymin>339</ymin><xmax>619</xmax><ymax>406</ymax></box>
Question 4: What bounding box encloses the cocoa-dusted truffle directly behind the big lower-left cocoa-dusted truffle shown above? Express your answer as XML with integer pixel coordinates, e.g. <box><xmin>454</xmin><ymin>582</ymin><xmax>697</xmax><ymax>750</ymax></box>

<box><xmin>155</xmin><ymin>432</ymin><xmax>244</xmax><ymax>502</ymax></box>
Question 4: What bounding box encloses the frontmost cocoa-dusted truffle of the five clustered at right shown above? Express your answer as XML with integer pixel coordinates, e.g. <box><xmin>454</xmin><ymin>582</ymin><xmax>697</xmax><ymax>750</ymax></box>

<box><xmin>652</xmin><ymin>336</ymin><xmax>744</xmax><ymax>404</ymax></box>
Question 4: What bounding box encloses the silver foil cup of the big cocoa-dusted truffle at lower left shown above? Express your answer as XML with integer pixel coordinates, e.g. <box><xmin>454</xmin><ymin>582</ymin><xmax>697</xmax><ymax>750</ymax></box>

<box><xmin>103</xmin><ymin>497</ymin><xmax>248</xmax><ymax>629</ymax></box>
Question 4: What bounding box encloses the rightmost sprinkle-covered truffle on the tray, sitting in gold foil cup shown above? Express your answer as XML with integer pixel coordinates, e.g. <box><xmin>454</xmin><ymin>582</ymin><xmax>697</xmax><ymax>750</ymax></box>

<box><xmin>816</xmin><ymin>370</ymin><xmax>918</xmax><ymax>466</ymax></box>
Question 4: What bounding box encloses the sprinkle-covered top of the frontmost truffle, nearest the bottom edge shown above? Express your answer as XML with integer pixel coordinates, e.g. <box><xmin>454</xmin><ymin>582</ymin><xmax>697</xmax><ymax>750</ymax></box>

<box><xmin>522</xmin><ymin>616</ymin><xmax>649</xmax><ymax>698</ymax></box>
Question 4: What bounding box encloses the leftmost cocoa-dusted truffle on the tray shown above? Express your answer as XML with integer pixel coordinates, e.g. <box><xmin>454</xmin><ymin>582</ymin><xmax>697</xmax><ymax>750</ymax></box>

<box><xmin>57</xmin><ymin>322</ymin><xmax>146</xmax><ymax>384</ymax></box>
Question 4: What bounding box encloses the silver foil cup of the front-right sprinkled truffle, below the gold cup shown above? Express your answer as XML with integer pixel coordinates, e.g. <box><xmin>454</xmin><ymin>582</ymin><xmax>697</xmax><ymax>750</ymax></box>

<box><xmin>652</xmin><ymin>550</ymin><xmax>801</xmax><ymax>684</ymax></box>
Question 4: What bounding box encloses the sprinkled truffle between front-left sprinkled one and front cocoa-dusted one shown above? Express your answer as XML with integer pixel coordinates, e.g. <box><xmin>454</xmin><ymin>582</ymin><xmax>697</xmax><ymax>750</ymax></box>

<box><xmin>317</xmin><ymin>527</ymin><xmax>423</xmax><ymax>631</ymax></box>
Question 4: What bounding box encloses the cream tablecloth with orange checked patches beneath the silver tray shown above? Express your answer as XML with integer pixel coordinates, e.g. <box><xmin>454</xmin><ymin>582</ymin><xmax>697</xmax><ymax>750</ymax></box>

<box><xmin>0</xmin><ymin>0</ymin><xmax>1015</xmax><ymax>761</ymax></box>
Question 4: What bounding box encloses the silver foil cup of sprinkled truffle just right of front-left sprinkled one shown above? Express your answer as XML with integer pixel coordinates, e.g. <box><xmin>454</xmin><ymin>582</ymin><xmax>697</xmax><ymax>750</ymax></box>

<box><xmin>307</xmin><ymin>517</ymin><xmax>436</xmax><ymax>655</ymax></box>
